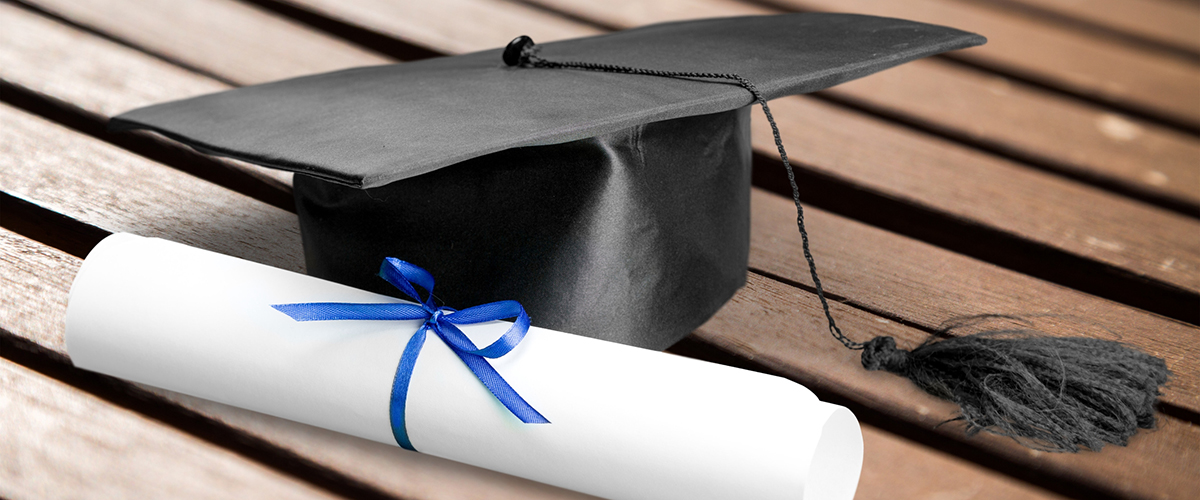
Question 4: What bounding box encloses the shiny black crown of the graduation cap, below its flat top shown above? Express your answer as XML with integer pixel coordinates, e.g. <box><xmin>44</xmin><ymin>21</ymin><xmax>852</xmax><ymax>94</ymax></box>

<box><xmin>295</xmin><ymin>108</ymin><xmax>750</xmax><ymax>349</ymax></box>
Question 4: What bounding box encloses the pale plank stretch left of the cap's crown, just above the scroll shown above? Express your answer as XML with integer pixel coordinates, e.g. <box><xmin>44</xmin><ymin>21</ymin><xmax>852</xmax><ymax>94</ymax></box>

<box><xmin>0</xmin><ymin>106</ymin><xmax>304</xmax><ymax>272</ymax></box>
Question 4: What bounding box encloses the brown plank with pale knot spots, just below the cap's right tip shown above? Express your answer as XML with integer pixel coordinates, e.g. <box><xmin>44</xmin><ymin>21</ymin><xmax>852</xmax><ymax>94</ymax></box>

<box><xmin>523</xmin><ymin>0</ymin><xmax>1200</xmax><ymax>212</ymax></box>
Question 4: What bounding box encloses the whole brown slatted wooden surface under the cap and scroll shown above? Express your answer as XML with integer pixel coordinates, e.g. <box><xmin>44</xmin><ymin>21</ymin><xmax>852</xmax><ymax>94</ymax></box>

<box><xmin>0</xmin><ymin>0</ymin><xmax>1200</xmax><ymax>499</ymax></box>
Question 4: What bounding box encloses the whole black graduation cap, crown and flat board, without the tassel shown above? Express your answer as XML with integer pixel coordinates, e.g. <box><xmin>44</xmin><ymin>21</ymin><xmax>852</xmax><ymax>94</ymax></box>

<box><xmin>109</xmin><ymin>13</ymin><xmax>984</xmax><ymax>349</ymax></box>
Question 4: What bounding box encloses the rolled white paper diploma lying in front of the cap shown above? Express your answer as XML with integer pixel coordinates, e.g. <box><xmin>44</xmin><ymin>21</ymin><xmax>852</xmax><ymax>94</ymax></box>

<box><xmin>66</xmin><ymin>234</ymin><xmax>863</xmax><ymax>500</ymax></box>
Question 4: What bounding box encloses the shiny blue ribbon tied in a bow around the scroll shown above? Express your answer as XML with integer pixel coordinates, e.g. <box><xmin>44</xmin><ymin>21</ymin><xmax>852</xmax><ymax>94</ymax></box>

<box><xmin>271</xmin><ymin>257</ymin><xmax>550</xmax><ymax>451</ymax></box>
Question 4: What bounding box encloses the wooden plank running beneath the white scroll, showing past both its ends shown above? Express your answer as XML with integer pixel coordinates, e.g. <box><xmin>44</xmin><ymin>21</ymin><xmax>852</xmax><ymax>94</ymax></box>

<box><xmin>0</xmin><ymin>229</ymin><xmax>1058</xmax><ymax>500</ymax></box>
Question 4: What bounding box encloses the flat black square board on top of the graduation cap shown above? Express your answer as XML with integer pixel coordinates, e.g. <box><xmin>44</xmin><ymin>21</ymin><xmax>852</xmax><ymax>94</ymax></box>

<box><xmin>110</xmin><ymin>13</ymin><xmax>984</xmax><ymax>187</ymax></box>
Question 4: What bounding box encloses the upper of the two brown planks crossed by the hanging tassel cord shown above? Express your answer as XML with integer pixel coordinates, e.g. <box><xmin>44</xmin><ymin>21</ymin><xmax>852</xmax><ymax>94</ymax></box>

<box><xmin>241</xmin><ymin>0</ymin><xmax>1200</xmax><ymax>311</ymax></box>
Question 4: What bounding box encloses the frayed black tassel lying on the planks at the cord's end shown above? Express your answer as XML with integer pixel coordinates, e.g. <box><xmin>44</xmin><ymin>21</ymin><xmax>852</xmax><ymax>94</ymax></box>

<box><xmin>863</xmin><ymin>323</ymin><xmax>1170</xmax><ymax>452</ymax></box>
